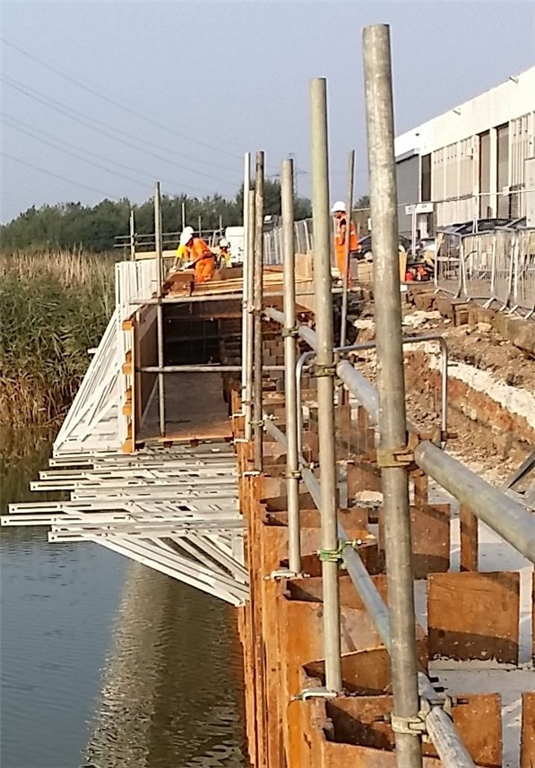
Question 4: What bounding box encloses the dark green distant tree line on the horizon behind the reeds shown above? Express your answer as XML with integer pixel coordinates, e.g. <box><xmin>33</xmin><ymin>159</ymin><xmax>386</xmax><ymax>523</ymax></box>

<box><xmin>0</xmin><ymin>179</ymin><xmax>311</xmax><ymax>253</ymax></box>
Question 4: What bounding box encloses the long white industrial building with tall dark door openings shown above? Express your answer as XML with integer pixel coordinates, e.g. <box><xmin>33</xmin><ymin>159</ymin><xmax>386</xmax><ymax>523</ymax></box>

<box><xmin>395</xmin><ymin>67</ymin><xmax>535</xmax><ymax>237</ymax></box>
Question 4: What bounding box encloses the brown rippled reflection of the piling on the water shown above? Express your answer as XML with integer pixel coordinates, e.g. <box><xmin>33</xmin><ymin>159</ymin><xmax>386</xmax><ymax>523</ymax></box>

<box><xmin>85</xmin><ymin>563</ymin><xmax>245</xmax><ymax>768</ymax></box>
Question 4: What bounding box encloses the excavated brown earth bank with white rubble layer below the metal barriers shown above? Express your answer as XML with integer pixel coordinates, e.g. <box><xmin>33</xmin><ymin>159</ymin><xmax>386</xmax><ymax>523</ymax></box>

<box><xmin>356</xmin><ymin>292</ymin><xmax>535</xmax><ymax>484</ymax></box>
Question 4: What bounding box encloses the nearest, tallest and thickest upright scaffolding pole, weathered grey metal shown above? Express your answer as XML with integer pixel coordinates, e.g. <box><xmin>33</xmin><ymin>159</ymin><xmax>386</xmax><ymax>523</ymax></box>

<box><xmin>363</xmin><ymin>24</ymin><xmax>422</xmax><ymax>768</ymax></box>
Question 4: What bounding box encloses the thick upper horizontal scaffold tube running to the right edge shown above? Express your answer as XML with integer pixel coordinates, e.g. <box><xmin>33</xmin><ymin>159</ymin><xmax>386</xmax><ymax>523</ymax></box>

<box><xmin>266</xmin><ymin>308</ymin><xmax>535</xmax><ymax>563</ymax></box>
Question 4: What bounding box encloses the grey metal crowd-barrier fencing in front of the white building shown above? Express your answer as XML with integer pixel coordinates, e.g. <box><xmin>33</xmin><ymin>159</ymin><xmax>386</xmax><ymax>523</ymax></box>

<box><xmin>435</xmin><ymin>228</ymin><xmax>535</xmax><ymax>316</ymax></box>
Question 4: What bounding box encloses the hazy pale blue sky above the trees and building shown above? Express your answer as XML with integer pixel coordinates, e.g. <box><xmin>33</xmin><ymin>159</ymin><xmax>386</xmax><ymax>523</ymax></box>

<box><xmin>0</xmin><ymin>0</ymin><xmax>535</xmax><ymax>222</ymax></box>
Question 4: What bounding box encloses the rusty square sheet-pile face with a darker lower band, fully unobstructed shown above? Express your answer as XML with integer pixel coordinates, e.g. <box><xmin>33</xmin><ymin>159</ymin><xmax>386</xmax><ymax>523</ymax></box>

<box><xmin>428</xmin><ymin>572</ymin><xmax>520</xmax><ymax>664</ymax></box>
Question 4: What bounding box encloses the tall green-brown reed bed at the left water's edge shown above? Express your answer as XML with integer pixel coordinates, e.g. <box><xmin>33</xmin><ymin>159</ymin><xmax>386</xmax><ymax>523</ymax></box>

<box><xmin>0</xmin><ymin>252</ymin><xmax>114</xmax><ymax>427</ymax></box>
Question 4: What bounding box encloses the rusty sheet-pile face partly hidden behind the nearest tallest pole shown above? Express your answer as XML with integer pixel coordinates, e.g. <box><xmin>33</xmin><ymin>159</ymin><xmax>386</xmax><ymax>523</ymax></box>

<box><xmin>379</xmin><ymin>504</ymin><xmax>451</xmax><ymax>579</ymax></box>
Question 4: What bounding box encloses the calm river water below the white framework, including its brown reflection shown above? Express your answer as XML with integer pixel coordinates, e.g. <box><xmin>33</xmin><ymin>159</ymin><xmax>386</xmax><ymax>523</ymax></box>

<box><xmin>0</xmin><ymin>434</ymin><xmax>246</xmax><ymax>768</ymax></box>
